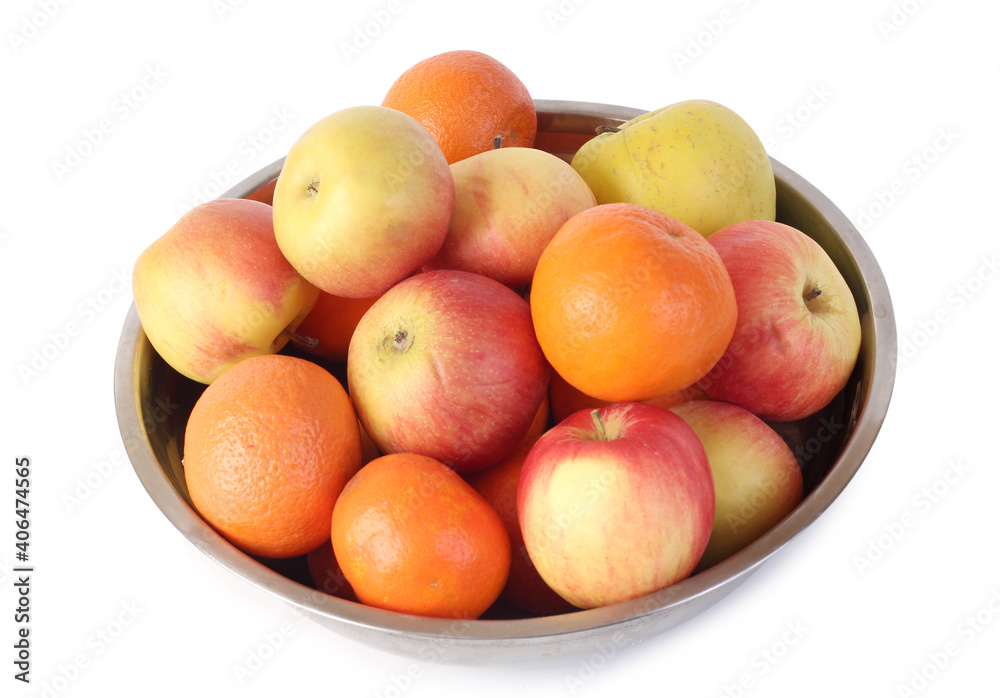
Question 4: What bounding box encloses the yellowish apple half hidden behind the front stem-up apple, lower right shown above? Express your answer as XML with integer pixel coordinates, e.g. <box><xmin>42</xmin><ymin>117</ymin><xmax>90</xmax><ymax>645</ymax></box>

<box><xmin>670</xmin><ymin>400</ymin><xmax>802</xmax><ymax>569</ymax></box>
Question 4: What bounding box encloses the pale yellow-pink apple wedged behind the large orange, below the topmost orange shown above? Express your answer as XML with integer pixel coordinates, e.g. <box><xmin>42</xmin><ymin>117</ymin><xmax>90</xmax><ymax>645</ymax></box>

<box><xmin>424</xmin><ymin>148</ymin><xmax>596</xmax><ymax>288</ymax></box>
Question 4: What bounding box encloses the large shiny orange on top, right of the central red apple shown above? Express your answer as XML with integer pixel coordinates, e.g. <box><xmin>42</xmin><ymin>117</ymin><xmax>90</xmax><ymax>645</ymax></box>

<box><xmin>530</xmin><ymin>204</ymin><xmax>736</xmax><ymax>402</ymax></box>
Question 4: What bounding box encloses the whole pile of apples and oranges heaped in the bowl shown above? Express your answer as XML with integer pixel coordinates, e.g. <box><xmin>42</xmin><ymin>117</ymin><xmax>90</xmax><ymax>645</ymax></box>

<box><xmin>133</xmin><ymin>51</ymin><xmax>861</xmax><ymax>618</ymax></box>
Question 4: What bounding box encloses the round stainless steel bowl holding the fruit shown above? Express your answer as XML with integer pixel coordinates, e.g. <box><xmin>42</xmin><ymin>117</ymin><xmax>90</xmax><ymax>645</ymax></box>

<box><xmin>115</xmin><ymin>100</ymin><xmax>896</xmax><ymax>664</ymax></box>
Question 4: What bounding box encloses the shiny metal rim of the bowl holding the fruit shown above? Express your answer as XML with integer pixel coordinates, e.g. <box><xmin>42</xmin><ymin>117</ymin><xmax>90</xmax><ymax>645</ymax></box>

<box><xmin>114</xmin><ymin>100</ymin><xmax>896</xmax><ymax>660</ymax></box>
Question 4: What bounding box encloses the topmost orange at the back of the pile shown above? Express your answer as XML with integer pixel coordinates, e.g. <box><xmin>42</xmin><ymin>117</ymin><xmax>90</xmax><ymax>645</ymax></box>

<box><xmin>382</xmin><ymin>51</ymin><xmax>538</xmax><ymax>164</ymax></box>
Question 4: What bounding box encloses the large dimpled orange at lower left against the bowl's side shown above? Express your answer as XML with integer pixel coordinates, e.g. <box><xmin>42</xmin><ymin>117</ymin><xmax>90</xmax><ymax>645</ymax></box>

<box><xmin>183</xmin><ymin>354</ymin><xmax>361</xmax><ymax>558</ymax></box>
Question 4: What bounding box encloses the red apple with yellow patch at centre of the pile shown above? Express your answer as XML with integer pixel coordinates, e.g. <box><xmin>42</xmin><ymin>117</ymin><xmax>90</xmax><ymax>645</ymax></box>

<box><xmin>347</xmin><ymin>270</ymin><xmax>549</xmax><ymax>473</ymax></box>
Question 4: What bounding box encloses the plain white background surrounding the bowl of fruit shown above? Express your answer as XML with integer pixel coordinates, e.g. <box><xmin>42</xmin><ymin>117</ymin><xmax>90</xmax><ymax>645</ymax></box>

<box><xmin>0</xmin><ymin>0</ymin><xmax>1000</xmax><ymax>698</ymax></box>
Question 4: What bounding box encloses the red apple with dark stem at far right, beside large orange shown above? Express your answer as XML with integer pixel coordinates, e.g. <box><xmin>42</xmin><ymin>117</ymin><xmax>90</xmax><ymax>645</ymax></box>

<box><xmin>699</xmin><ymin>221</ymin><xmax>861</xmax><ymax>422</ymax></box>
